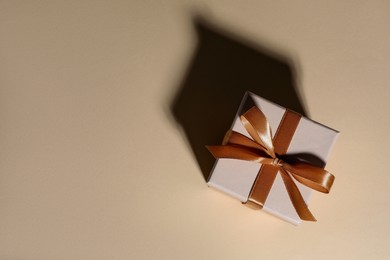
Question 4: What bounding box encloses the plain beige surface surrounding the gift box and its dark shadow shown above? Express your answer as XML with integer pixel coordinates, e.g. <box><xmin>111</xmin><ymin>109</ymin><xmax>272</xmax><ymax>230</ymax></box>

<box><xmin>0</xmin><ymin>0</ymin><xmax>390</xmax><ymax>260</ymax></box>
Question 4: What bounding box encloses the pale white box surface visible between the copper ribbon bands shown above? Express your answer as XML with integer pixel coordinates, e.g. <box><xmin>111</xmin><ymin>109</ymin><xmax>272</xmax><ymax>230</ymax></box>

<box><xmin>208</xmin><ymin>92</ymin><xmax>339</xmax><ymax>225</ymax></box>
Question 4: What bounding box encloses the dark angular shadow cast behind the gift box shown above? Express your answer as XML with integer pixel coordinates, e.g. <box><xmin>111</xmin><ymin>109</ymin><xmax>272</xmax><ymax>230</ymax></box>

<box><xmin>170</xmin><ymin>18</ymin><xmax>306</xmax><ymax>180</ymax></box>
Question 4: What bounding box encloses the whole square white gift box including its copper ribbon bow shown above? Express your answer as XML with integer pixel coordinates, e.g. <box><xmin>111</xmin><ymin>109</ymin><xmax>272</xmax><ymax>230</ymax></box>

<box><xmin>208</xmin><ymin>92</ymin><xmax>339</xmax><ymax>225</ymax></box>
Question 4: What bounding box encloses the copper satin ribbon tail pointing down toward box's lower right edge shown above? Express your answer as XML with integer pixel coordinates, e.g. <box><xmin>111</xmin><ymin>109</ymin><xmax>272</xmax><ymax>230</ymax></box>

<box><xmin>280</xmin><ymin>169</ymin><xmax>317</xmax><ymax>221</ymax></box>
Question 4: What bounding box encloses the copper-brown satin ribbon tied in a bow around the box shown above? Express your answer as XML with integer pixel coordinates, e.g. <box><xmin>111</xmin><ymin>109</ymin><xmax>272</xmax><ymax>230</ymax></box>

<box><xmin>207</xmin><ymin>106</ymin><xmax>335</xmax><ymax>221</ymax></box>
